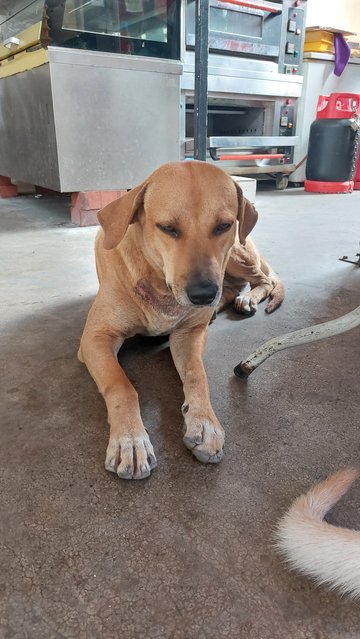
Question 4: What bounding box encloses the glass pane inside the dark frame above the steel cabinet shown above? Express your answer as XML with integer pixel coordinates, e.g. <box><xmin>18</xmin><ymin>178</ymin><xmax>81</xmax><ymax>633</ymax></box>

<box><xmin>62</xmin><ymin>0</ymin><xmax>168</xmax><ymax>42</ymax></box>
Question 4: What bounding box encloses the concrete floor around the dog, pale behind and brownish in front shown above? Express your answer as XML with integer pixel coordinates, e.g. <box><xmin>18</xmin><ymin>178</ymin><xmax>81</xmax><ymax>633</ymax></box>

<box><xmin>0</xmin><ymin>188</ymin><xmax>360</xmax><ymax>639</ymax></box>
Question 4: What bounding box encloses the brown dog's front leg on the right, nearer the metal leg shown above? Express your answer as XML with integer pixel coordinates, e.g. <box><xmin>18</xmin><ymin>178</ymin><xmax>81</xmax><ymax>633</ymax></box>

<box><xmin>170</xmin><ymin>324</ymin><xmax>225</xmax><ymax>464</ymax></box>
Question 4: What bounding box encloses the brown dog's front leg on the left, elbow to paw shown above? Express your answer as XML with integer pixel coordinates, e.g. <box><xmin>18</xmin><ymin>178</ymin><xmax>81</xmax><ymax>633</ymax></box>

<box><xmin>79</xmin><ymin>329</ymin><xmax>156</xmax><ymax>479</ymax></box>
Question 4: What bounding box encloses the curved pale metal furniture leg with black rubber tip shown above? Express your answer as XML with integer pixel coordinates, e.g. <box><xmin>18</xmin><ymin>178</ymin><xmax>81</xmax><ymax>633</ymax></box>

<box><xmin>234</xmin><ymin>306</ymin><xmax>360</xmax><ymax>377</ymax></box>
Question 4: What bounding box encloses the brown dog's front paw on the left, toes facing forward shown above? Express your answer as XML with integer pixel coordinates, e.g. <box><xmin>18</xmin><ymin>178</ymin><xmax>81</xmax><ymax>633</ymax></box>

<box><xmin>105</xmin><ymin>430</ymin><xmax>157</xmax><ymax>479</ymax></box>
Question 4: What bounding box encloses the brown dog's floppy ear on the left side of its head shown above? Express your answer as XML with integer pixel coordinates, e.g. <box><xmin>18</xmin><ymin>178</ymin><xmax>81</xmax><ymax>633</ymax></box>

<box><xmin>98</xmin><ymin>182</ymin><xmax>147</xmax><ymax>249</ymax></box>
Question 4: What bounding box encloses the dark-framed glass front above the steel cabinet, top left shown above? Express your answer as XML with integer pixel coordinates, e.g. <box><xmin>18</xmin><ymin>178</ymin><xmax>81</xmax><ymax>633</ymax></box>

<box><xmin>47</xmin><ymin>0</ymin><xmax>180</xmax><ymax>59</ymax></box>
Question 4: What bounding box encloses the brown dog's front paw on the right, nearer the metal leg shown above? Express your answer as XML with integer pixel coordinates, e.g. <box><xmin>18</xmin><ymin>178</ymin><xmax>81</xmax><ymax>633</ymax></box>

<box><xmin>184</xmin><ymin>418</ymin><xmax>225</xmax><ymax>464</ymax></box>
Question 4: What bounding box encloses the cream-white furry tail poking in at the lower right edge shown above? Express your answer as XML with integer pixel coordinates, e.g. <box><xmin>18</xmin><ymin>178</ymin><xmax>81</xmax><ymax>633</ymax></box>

<box><xmin>276</xmin><ymin>468</ymin><xmax>360</xmax><ymax>598</ymax></box>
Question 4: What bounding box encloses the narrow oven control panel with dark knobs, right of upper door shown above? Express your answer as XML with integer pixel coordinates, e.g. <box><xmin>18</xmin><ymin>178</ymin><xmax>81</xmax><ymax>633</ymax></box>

<box><xmin>284</xmin><ymin>2</ymin><xmax>305</xmax><ymax>75</ymax></box>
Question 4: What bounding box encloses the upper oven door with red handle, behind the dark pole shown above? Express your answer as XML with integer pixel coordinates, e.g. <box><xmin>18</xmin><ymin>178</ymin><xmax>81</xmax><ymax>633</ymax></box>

<box><xmin>186</xmin><ymin>0</ymin><xmax>282</xmax><ymax>58</ymax></box>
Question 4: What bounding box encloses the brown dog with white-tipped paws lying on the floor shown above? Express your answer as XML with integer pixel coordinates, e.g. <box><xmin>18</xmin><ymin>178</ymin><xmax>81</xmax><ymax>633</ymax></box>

<box><xmin>79</xmin><ymin>162</ymin><xmax>283</xmax><ymax>479</ymax></box>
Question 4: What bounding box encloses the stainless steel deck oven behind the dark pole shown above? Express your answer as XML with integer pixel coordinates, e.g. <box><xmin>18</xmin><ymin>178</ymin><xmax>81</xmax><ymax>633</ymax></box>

<box><xmin>181</xmin><ymin>0</ymin><xmax>306</xmax><ymax>188</ymax></box>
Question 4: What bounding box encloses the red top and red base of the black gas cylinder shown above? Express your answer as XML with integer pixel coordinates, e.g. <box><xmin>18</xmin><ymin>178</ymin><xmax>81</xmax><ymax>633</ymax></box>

<box><xmin>304</xmin><ymin>93</ymin><xmax>360</xmax><ymax>193</ymax></box>
